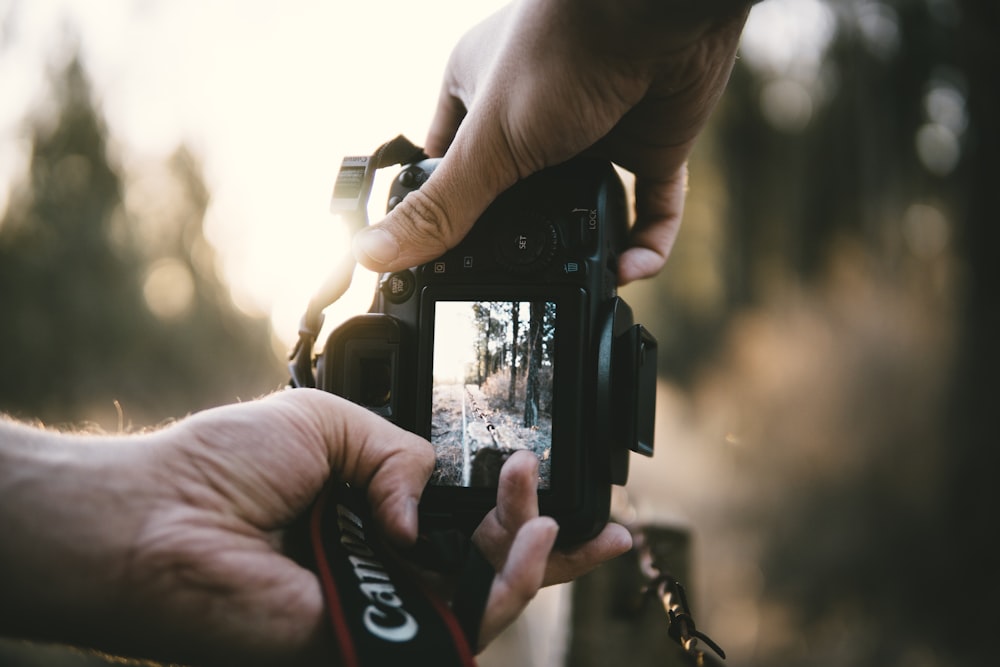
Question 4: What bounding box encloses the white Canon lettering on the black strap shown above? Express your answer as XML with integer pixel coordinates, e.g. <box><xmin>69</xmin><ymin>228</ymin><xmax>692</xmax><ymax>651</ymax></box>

<box><xmin>337</xmin><ymin>503</ymin><xmax>420</xmax><ymax>642</ymax></box>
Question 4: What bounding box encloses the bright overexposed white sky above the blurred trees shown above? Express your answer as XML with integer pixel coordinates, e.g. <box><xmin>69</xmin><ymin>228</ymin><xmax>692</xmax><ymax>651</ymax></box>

<box><xmin>0</xmin><ymin>0</ymin><xmax>828</xmax><ymax>341</ymax></box>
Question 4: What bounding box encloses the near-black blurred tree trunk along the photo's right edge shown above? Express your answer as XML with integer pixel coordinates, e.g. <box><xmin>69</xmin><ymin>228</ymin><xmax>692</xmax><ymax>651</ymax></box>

<box><xmin>942</xmin><ymin>0</ymin><xmax>1000</xmax><ymax>664</ymax></box>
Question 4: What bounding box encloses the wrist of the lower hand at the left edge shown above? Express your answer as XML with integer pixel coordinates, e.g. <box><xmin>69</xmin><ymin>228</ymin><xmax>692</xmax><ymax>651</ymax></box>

<box><xmin>0</xmin><ymin>422</ymin><xmax>157</xmax><ymax>646</ymax></box>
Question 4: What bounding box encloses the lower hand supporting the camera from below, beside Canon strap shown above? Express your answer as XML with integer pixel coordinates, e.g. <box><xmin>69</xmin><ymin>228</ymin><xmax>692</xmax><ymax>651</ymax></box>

<box><xmin>0</xmin><ymin>389</ymin><xmax>613</xmax><ymax>665</ymax></box>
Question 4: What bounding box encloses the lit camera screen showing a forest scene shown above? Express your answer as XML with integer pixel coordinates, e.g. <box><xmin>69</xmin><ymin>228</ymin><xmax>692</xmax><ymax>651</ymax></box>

<box><xmin>430</xmin><ymin>301</ymin><xmax>556</xmax><ymax>489</ymax></box>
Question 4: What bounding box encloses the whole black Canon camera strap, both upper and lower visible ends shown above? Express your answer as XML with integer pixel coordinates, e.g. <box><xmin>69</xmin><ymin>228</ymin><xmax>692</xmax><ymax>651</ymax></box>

<box><xmin>289</xmin><ymin>135</ymin><xmax>495</xmax><ymax>667</ymax></box>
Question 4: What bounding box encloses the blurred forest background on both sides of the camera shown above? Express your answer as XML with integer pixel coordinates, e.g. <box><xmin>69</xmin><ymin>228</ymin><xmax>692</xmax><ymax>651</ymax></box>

<box><xmin>0</xmin><ymin>0</ymin><xmax>1000</xmax><ymax>667</ymax></box>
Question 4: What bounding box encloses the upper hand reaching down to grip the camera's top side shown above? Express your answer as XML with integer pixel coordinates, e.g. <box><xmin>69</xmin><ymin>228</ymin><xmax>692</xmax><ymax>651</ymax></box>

<box><xmin>354</xmin><ymin>0</ymin><xmax>749</xmax><ymax>284</ymax></box>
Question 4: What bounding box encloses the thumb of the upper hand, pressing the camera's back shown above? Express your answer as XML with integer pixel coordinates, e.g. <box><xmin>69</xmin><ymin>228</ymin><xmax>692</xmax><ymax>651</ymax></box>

<box><xmin>353</xmin><ymin>133</ymin><xmax>518</xmax><ymax>273</ymax></box>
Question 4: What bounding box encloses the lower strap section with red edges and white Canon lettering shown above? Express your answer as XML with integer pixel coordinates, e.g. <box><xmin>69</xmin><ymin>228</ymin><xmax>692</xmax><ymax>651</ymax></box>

<box><xmin>309</xmin><ymin>483</ymin><xmax>482</xmax><ymax>667</ymax></box>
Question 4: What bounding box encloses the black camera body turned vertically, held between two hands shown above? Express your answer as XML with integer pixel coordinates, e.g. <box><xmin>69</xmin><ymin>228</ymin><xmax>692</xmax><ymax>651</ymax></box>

<box><xmin>316</xmin><ymin>158</ymin><xmax>656</xmax><ymax>544</ymax></box>
